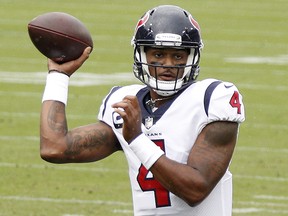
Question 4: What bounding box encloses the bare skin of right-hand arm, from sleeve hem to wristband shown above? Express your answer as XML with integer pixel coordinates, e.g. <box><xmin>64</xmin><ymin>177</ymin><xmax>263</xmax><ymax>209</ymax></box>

<box><xmin>150</xmin><ymin>121</ymin><xmax>238</xmax><ymax>206</ymax></box>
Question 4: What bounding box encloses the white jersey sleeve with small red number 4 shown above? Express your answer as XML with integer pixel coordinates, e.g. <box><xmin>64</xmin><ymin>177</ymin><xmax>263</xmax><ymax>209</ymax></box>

<box><xmin>205</xmin><ymin>82</ymin><xmax>245</xmax><ymax>123</ymax></box>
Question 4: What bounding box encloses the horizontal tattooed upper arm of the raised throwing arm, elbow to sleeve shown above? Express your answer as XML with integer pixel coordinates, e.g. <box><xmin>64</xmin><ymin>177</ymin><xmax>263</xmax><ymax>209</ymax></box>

<box><xmin>41</xmin><ymin>119</ymin><xmax>120</xmax><ymax>163</ymax></box>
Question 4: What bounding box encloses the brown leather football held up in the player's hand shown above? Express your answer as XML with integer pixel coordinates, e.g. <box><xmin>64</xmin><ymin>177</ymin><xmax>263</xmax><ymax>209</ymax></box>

<box><xmin>28</xmin><ymin>12</ymin><xmax>93</xmax><ymax>63</ymax></box>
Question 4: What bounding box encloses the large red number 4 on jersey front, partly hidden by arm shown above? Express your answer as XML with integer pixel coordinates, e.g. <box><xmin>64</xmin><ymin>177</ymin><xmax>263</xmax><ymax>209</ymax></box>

<box><xmin>137</xmin><ymin>140</ymin><xmax>171</xmax><ymax>208</ymax></box>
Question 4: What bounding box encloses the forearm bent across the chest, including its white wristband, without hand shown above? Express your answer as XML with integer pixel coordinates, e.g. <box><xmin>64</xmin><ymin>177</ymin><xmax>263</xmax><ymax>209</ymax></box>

<box><xmin>129</xmin><ymin>134</ymin><xmax>213</xmax><ymax>206</ymax></box>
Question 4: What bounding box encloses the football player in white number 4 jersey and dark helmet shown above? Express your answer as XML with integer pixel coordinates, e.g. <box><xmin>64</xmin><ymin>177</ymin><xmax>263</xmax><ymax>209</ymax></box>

<box><xmin>40</xmin><ymin>5</ymin><xmax>245</xmax><ymax>216</ymax></box>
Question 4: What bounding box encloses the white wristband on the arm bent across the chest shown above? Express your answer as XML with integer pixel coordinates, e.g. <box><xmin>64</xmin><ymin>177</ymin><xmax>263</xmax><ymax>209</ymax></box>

<box><xmin>129</xmin><ymin>133</ymin><xmax>164</xmax><ymax>170</ymax></box>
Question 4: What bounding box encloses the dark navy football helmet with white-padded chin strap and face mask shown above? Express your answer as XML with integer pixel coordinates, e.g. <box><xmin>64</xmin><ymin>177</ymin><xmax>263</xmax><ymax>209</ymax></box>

<box><xmin>131</xmin><ymin>5</ymin><xmax>204</xmax><ymax>96</ymax></box>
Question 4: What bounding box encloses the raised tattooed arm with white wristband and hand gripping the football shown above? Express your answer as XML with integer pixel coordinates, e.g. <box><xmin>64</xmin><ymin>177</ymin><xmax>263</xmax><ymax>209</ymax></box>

<box><xmin>40</xmin><ymin>47</ymin><xmax>120</xmax><ymax>163</ymax></box>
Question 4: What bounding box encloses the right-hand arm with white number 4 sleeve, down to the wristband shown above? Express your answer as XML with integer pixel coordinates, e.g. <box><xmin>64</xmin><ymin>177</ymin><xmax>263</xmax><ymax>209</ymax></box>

<box><xmin>150</xmin><ymin>82</ymin><xmax>245</xmax><ymax>206</ymax></box>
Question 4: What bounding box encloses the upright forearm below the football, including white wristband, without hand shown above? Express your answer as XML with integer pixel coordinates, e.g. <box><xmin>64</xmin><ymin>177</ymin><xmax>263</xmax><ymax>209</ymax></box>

<box><xmin>40</xmin><ymin>71</ymin><xmax>73</xmax><ymax>163</ymax></box>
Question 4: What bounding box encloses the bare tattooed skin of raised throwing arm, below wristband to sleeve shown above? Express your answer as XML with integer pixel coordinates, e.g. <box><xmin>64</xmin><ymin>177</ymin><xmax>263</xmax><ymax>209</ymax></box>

<box><xmin>40</xmin><ymin>100</ymin><xmax>119</xmax><ymax>163</ymax></box>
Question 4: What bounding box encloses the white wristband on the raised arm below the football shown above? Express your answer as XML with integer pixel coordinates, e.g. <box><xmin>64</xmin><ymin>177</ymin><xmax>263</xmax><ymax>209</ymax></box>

<box><xmin>42</xmin><ymin>70</ymin><xmax>69</xmax><ymax>105</ymax></box>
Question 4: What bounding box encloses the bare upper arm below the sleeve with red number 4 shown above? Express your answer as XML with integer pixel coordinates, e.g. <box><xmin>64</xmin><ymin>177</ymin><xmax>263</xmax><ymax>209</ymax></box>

<box><xmin>188</xmin><ymin>121</ymin><xmax>238</xmax><ymax>186</ymax></box>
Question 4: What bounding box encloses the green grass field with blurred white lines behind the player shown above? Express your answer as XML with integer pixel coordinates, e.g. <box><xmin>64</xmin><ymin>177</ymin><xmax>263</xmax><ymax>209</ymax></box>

<box><xmin>0</xmin><ymin>0</ymin><xmax>288</xmax><ymax>216</ymax></box>
